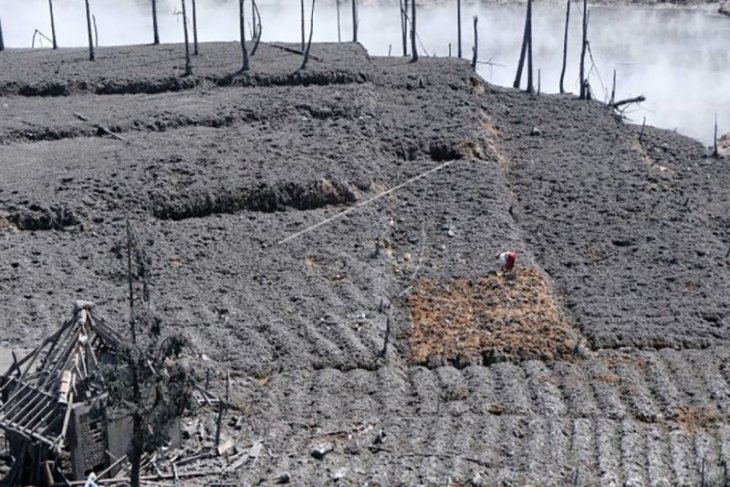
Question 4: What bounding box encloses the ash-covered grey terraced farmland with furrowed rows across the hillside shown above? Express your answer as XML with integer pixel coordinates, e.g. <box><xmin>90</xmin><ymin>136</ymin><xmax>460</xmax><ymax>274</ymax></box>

<box><xmin>0</xmin><ymin>44</ymin><xmax>730</xmax><ymax>485</ymax></box>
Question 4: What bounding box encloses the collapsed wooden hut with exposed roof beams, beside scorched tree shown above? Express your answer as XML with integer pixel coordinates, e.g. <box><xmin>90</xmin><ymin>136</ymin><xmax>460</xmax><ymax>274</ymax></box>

<box><xmin>0</xmin><ymin>301</ymin><xmax>131</xmax><ymax>485</ymax></box>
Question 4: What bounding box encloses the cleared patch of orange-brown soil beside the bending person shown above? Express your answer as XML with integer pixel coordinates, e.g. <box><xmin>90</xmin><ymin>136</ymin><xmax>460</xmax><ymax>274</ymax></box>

<box><xmin>406</xmin><ymin>268</ymin><xmax>580</xmax><ymax>366</ymax></box>
